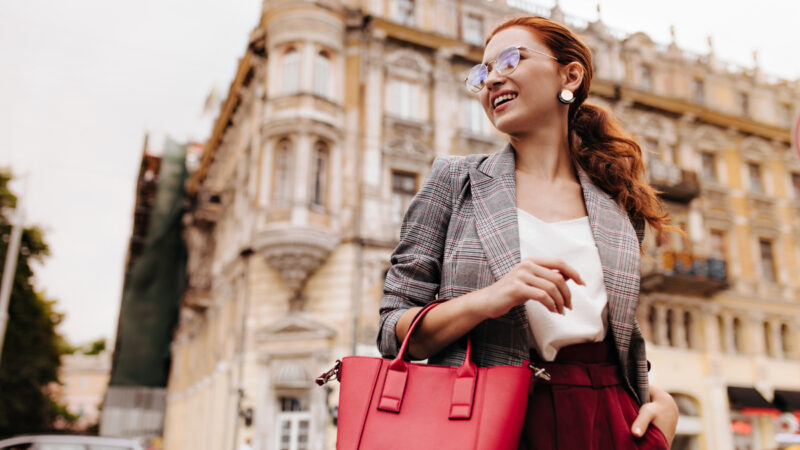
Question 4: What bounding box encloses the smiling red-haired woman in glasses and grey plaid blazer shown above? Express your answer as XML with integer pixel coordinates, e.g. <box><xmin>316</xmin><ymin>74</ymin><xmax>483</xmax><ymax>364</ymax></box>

<box><xmin>378</xmin><ymin>17</ymin><xmax>678</xmax><ymax>449</ymax></box>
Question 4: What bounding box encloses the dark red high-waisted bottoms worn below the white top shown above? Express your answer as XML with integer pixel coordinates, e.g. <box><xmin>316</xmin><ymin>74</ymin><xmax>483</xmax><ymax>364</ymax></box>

<box><xmin>520</xmin><ymin>339</ymin><xmax>669</xmax><ymax>450</ymax></box>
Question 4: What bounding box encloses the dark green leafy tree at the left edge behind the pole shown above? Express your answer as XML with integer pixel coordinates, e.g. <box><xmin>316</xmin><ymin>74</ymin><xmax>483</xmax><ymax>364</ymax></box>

<box><xmin>0</xmin><ymin>171</ymin><xmax>69</xmax><ymax>438</ymax></box>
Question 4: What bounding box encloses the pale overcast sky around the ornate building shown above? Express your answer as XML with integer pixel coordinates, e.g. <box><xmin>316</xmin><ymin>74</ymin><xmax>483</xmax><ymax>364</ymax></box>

<box><xmin>0</xmin><ymin>0</ymin><xmax>800</xmax><ymax>344</ymax></box>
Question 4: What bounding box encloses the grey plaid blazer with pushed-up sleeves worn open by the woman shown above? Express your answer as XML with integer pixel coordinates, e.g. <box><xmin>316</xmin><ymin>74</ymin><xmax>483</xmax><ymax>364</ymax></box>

<box><xmin>377</xmin><ymin>144</ymin><xmax>649</xmax><ymax>403</ymax></box>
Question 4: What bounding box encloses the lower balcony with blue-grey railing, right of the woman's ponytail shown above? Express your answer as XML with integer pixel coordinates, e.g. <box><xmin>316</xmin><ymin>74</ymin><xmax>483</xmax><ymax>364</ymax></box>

<box><xmin>641</xmin><ymin>251</ymin><xmax>729</xmax><ymax>297</ymax></box>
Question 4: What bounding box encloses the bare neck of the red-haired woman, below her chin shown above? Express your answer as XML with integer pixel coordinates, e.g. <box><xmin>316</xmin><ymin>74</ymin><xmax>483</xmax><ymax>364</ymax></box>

<box><xmin>510</xmin><ymin>113</ymin><xmax>577</xmax><ymax>181</ymax></box>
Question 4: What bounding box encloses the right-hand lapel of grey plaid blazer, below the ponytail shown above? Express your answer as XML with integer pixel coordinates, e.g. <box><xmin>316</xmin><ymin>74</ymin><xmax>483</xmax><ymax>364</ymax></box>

<box><xmin>578</xmin><ymin>169</ymin><xmax>640</xmax><ymax>373</ymax></box>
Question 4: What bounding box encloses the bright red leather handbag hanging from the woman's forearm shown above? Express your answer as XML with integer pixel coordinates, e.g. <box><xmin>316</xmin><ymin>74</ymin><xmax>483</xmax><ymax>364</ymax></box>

<box><xmin>317</xmin><ymin>302</ymin><xmax>549</xmax><ymax>450</ymax></box>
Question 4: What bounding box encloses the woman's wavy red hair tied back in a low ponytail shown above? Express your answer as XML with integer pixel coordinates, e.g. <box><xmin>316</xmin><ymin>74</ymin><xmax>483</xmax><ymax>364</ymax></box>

<box><xmin>486</xmin><ymin>16</ymin><xmax>681</xmax><ymax>246</ymax></box>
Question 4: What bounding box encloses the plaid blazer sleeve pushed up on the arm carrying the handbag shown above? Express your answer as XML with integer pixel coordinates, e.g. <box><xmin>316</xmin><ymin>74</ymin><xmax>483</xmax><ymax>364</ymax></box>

<box><xmin>377</xmin><ymin>157</ymin><xmax>454</xmax><ymax>358</ymax></box>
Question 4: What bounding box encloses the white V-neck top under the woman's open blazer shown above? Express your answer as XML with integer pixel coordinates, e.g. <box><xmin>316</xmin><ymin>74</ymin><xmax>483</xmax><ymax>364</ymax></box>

<box><xmin>517</xmin><ymin>208</ymin><xmax>608</xmax><ymax>361</ymax></box>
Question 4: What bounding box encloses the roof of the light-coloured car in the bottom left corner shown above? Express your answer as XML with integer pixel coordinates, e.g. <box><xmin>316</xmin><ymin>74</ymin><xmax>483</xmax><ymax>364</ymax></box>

<box><xmin>0</xmin><ymin>434</ymin><xmax>143</xmax><ymax>450</ymax></box>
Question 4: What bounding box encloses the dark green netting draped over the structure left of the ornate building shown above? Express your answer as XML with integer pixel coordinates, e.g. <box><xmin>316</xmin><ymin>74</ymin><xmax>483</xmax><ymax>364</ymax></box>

<box><xmin>109</xmin><ymin>139</ymin><xmax>187</xmax><ymax>387</ymax></box>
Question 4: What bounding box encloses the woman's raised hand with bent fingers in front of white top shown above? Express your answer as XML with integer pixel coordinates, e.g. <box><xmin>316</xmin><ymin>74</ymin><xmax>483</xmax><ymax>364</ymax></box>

<box><xmin>484</xmin><ymin>256</ymin><xmax>586</xmax><ymax>318</ymax></box>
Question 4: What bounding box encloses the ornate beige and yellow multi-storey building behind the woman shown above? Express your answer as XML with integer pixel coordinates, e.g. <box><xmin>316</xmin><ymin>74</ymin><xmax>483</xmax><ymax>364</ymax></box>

<box><xmin>165</xmin><ymin>0</ymin><xmax>800</xmax><ymax>450</ymax></box>
